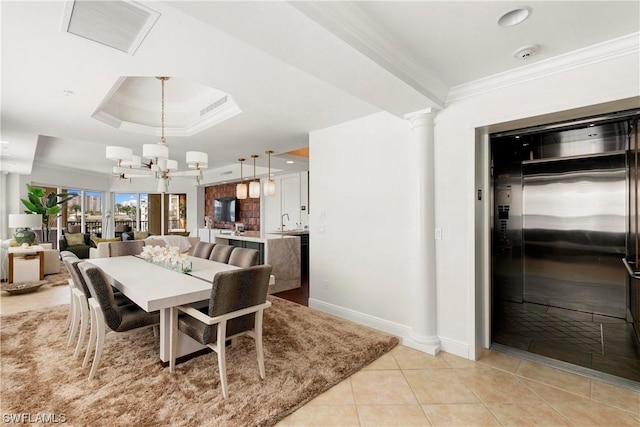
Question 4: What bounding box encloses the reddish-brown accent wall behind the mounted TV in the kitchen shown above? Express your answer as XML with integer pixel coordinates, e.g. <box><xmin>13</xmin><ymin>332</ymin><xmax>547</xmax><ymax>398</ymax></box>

<box><xmin>204</xmin><ymin>180</ymin><xmax>260</xmax><ymax>231</ymax></box>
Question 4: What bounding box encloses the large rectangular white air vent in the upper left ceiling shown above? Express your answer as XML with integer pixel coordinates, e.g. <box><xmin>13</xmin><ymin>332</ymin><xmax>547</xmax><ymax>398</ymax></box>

<box><xmin>62</xmin><ymin>0</ymin><xmax>160</xmax><ymax>55</ymax></box>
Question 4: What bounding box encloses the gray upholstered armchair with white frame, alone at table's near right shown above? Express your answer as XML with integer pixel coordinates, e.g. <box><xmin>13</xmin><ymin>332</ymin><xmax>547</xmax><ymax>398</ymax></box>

<box><xmin>169</xmin><ymin>264</ymin><xmax>271</xmax><ymax>398</ymax></box>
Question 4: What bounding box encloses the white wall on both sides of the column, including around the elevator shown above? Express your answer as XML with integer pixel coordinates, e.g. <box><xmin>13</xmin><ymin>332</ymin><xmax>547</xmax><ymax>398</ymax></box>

<box><xmin>310</xmin><ymin>45</ymin><xmax>640</xmax><ymax>358</ymax></box>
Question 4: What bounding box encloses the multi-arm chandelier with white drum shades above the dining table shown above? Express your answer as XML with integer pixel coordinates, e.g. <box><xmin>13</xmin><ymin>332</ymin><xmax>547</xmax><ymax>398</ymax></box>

<box><xmin>106</xmin><ymin>77</ymin><xmax>209</xmax><ymax>193</ymax></box>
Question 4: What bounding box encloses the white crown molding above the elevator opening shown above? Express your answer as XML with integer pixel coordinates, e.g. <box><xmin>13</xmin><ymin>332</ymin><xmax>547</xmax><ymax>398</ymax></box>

<box><xmin>447</xmin><ymin>33</ymin><xmax>640</xmax><ymax>103</ymax></box>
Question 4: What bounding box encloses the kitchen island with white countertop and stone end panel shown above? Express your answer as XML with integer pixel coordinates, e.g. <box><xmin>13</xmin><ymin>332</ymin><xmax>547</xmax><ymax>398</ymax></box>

<box><xmin>198</xmin><ymin>228</ymin><xmax>301</xmax><ymax>293</ymax></box>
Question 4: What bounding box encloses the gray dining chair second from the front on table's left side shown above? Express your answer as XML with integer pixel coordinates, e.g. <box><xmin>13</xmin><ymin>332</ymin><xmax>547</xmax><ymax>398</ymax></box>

<box><xmin>62</xmin><ymin>257</ymin><xmax>132</xmax><ymax>357</ymax></box>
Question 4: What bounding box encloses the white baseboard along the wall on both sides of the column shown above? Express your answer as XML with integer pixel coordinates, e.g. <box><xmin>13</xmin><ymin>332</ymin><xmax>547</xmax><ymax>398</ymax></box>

<box><xmin>309</xmin><ymin>298</ymin><xmax>469</xmax><ymax>359</ymax></box>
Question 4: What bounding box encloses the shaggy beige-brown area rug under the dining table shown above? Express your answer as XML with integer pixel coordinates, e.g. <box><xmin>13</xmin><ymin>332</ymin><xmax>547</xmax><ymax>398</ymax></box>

<box><xmin>0</xmin><ymin>296</ymin><xmax>398</xmax><ymax>427</ymax></box>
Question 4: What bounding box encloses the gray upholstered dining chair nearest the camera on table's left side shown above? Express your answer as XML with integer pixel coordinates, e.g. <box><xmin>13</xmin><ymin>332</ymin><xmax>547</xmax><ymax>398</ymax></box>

<box><xmin>78</xmin><ymin>262</ymin><xmax>160</xmax><ymax>380</ymax></box>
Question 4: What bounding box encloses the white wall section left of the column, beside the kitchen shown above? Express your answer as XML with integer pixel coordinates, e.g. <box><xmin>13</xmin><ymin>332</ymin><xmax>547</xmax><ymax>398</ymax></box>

<box><xmin>309</xmin><ymin>113</ymin><xmax>420</xmax><ymax>334</ymax></box>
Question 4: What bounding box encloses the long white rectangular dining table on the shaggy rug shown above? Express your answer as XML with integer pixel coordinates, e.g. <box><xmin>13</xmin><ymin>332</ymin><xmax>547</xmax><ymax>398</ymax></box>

<box><xmin>88</xmin><ymin>255</ymin><xmax>238</xmax><ymax>362</ymax></box>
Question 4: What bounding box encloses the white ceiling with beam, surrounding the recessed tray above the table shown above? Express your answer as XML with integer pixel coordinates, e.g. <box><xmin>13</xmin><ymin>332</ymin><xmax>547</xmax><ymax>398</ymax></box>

<box><xmin>0</xmin><ymin>1</ymin><xmax>640</xmax><ymax>180</ymax></box>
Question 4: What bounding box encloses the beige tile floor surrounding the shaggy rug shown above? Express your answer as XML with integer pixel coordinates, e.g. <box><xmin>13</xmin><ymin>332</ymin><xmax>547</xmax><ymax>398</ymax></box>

<box><xmin>0</xmin><ymin>286</ymin><xmax>640</xmax><ymax>427</ymax></box>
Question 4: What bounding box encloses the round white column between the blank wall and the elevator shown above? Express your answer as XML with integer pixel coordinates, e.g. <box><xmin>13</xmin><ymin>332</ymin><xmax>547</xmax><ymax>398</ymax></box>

<box><xmin>405</xmin><ymin>108</ymin><xmax>440</xmax><ymax>355</ymax></box>
